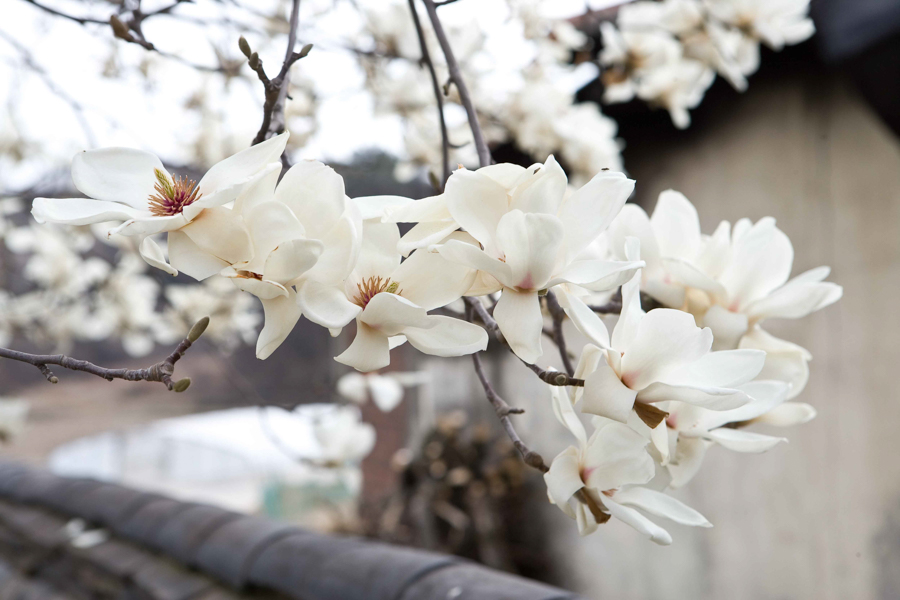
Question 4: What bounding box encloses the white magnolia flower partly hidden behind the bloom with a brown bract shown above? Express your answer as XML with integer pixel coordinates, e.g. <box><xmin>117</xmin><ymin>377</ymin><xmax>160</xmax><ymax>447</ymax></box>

<box><xmin>664</xmin><ymin>381</ymin><xmax>816</xmax><ymax>488</ymax></box>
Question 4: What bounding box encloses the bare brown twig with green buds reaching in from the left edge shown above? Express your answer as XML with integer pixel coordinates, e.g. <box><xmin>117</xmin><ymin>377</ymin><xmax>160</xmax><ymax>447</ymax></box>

<box><xmin>0</xmin><ymin>317</ymin><xmax>209</xmax><ymax>392</ymax></box>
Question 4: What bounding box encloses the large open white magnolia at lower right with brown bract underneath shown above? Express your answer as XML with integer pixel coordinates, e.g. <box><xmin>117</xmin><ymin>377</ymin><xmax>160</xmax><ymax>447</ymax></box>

<box><xmin>560</xmin><ymin>238</ymin><xmax>765</xmax><ymax>427</ymax></box>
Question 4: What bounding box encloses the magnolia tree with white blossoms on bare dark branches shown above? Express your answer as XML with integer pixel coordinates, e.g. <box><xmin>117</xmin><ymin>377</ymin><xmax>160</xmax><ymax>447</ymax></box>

<box><xmin>0</xmin><ymin>0</ymin><xmax>842</xmax><ymax>544</ymax></box>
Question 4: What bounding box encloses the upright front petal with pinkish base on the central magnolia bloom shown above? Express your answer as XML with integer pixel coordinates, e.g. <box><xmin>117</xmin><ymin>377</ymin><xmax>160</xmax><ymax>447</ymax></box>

<box><xmin>496</xmin><ymin>210</ymin><xmax>563</xmax><ymax>291</ymax></box>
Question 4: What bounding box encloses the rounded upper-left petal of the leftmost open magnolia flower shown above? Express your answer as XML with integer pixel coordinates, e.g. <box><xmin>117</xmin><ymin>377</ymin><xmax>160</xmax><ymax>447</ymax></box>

<box><xmin>72</xmin><ymin>148</ymin><xmax>169</xmax><ymax>210</ymax></box>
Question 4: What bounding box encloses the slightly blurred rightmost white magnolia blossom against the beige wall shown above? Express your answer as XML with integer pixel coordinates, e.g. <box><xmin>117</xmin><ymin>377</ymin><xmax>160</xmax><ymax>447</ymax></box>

<box><xmin>610</xmin><ymin>190</ymin><xmax>843</xmax><ymax>397</ymax></box>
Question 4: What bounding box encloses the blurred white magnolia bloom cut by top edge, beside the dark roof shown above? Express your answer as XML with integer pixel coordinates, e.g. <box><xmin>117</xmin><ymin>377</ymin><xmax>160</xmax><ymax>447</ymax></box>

<box><xmin>704</xmin><ymin>0</ymin><xmax>816</xmax><ymax>50</ymax></box>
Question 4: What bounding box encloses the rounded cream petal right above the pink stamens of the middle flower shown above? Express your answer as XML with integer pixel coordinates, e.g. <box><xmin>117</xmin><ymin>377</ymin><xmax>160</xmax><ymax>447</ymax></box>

<box><xmin>391</xmin><ymin>250</ymin><xmax>476</xmax><ymax>310</ymax></box>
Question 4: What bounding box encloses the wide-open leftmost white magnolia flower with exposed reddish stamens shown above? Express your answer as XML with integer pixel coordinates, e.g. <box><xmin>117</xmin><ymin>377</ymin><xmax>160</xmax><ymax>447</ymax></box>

<box><xmin>32</xmin><ymin>133</ymin><xmax>288</xmax><ymax>275</ymax></box>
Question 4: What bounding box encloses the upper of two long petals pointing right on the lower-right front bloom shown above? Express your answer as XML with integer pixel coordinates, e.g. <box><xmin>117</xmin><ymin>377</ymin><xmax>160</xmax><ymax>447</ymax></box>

<box><xmin>663</xmin><ymin>349</ymin><xmax>766</xmax><ymax>387</ymax></box>
